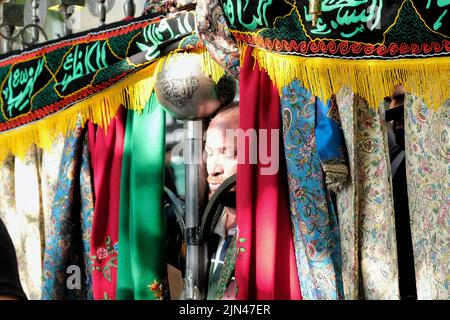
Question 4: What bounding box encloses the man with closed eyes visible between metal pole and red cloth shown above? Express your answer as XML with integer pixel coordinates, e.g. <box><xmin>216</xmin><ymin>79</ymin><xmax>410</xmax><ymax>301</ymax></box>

<box><xmin>205</xmin><ymin>102</ymin><xmax>239</xmax><ymax>300</ymax></box>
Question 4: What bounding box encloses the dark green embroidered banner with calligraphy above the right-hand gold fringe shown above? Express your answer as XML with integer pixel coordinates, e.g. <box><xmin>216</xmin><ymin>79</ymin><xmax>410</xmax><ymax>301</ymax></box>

<box><xmin>227</xmin><ymin>0</ymin><xmax>450</xmax><ymax>59</ymax></box>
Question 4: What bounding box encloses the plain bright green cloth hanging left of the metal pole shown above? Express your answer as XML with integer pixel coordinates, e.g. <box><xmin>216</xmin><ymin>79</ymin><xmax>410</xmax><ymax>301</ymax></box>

<box><xmin>117</xmin><ymin>94</ymin><xmax>167</xmax><ymax>300</ymax></box>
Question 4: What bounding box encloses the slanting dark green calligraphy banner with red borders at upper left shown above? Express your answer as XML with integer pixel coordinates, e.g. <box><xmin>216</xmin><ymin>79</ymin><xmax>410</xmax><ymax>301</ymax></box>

<box><xmin>0</xmin><ymin>12</ymin><xmax>201</xmax><ymax>135</ymax></box>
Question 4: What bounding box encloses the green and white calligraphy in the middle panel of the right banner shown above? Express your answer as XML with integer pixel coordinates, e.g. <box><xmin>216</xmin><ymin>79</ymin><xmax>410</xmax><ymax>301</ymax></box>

<box><xmin>303</xmin><ymin>0</ymin><xmax>384</xmax><ymax>39</ymax></box>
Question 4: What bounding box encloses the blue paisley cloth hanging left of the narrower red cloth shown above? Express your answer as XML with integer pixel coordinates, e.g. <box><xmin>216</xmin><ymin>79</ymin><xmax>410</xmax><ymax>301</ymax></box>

<box><xmin>42</xmin><ymin>124</ymin><xmax>93</xmax><ymax>300</ymax></box>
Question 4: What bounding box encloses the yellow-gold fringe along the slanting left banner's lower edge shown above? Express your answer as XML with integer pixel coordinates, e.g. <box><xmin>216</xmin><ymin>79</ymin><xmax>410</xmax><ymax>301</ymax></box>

<box><xmin>0</xmin><ymin>61</ymin><xmax>161</xmax><ymax>163</ymax></box>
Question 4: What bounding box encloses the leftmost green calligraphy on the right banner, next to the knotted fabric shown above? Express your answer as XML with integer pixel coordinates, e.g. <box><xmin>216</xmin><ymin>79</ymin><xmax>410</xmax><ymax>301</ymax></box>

<box><xmin>222</xmin><ymin>0</ymin><xmax>272</xmax><ymax>31</ymax></box>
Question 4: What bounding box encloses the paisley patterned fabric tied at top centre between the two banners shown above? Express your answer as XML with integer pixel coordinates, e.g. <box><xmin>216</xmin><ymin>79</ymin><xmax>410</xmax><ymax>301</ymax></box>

<box><xmin>195</xmin><ymin>0</ymin><xmax>240</xmax><ymax>79</ymax></box>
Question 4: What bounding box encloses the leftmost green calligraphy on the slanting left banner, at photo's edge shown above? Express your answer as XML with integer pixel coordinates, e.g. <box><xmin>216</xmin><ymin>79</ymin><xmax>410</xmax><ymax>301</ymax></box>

<box><xmin>2</xmin><ymin>58</ymin><xmax>45</xmax><ymax>118</ymax></box>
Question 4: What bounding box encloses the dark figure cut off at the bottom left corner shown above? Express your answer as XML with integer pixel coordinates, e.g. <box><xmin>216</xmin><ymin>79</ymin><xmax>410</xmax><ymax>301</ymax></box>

<box><xmin>0</xmin><ymin>219</ymin><xmax>27</xmax><ymax>300</ymax></box>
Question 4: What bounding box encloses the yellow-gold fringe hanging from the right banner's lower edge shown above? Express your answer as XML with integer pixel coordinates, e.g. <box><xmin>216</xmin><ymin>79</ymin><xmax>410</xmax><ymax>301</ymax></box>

<box><xmin>250</xmin><ymin>45</ymin><xmax>450</xmax><ymax>109</ymax></box>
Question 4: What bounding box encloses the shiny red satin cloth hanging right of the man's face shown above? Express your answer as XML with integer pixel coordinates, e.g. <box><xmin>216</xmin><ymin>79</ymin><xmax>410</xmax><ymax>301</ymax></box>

<box><xmin>235</xmin><ymin>49</ymin><xmax>301</xmax><ymax>300</ymax></box>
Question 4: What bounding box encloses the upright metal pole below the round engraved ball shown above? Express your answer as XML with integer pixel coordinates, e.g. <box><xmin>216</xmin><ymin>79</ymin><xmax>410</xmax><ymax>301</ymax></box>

<box><xmin>184</xmin><ymin>120</ymin><xmax>207</xmax><ymax>300</ymax></box>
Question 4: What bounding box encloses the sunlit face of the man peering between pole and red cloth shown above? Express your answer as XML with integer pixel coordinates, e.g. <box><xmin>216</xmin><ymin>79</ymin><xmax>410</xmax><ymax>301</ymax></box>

<box><xmin>205</xmin><ymin>114</ymin><xmax>238</xmax><ymax>195</ymax></box>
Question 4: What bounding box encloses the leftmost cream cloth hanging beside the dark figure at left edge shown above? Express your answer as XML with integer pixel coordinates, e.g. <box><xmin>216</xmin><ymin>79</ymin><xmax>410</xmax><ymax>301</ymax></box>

<box><xmin>0</xmin><ymin>145</ymin><xmax>43</xmax><ymax>300</ymax></box>
